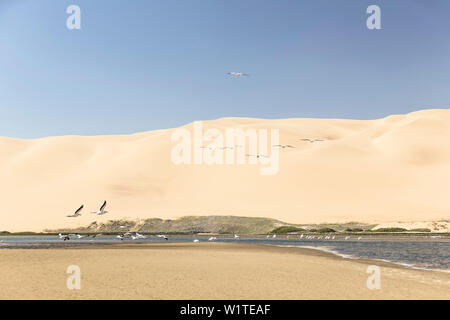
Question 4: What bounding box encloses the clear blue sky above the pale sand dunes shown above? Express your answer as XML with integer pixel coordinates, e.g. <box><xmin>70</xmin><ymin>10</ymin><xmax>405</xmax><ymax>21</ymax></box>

<box><xmin>0</xmin><ymin>0</ymin><xmax>450</xmax><ymax>138</ymax></box>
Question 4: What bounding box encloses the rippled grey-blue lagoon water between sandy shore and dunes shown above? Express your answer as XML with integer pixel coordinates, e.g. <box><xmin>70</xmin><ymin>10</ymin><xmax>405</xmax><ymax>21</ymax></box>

<box><xmin>0</xmin><ymin>236</ymin><xmax>450</xmax><ymax>272</ymax></box>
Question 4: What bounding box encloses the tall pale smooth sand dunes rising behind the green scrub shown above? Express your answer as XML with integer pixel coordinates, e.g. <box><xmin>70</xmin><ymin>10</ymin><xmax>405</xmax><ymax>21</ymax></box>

<box><xmin>0</xmin><ymin>109</ymin><xmax>450</xmax><ymax>231</ymax></box>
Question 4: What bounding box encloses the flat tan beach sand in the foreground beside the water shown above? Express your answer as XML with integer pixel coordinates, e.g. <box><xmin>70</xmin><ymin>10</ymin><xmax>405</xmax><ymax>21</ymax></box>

<box><xmin>0</xmin><ymin>243</ymin><xmax>450</xmax><ymax>299</ymax></box>
